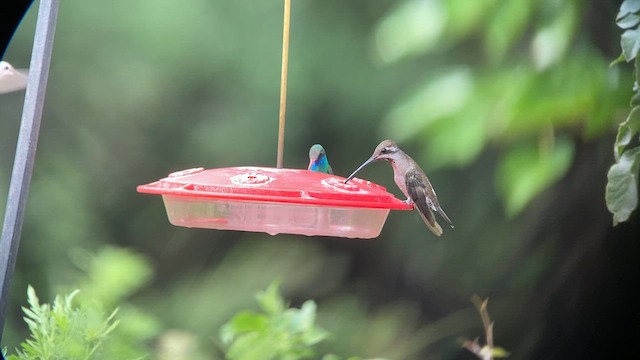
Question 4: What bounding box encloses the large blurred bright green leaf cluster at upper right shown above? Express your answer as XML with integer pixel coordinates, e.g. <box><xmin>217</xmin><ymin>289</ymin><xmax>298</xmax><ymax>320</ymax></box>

<box><xmin>376</xmin><ymin>0</ymin><xmax>617</xmax><ymax>216</ymax></box>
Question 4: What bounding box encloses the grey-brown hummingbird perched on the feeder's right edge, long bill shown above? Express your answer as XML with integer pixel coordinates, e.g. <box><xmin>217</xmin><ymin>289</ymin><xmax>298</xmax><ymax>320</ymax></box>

<box><xmin>344</xmin><ymin>140</ymin><xmax>453</xmax><ymax>236</ymax></box>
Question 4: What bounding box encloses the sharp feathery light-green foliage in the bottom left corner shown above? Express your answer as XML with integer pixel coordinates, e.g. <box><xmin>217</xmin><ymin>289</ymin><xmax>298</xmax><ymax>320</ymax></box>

<box><xmin>8</xmin><ymin>286</ymin><xmax>119</xmax><ymax>360</ymax></box>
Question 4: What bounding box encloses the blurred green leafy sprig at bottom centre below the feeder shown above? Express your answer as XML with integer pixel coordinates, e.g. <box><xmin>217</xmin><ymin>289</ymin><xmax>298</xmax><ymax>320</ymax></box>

<box><xmin>220</xmin><ymin>281</ymin><xmax>368</xmax><ymax>360</ymax></box>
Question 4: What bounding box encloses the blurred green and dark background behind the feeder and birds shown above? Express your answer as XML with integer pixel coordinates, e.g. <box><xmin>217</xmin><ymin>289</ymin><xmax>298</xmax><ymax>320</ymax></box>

<box><xmin>0</xmin><ymin>0</ymin><xmax>640</xmax><ymax>359</ymax></box>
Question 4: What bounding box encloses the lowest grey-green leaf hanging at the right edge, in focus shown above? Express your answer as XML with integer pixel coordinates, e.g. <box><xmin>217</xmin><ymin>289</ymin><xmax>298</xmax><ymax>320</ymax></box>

<box><xmin>605</xmin><ymin>147</ymin><xmax>640</xmax><ymax>226</ymax></box>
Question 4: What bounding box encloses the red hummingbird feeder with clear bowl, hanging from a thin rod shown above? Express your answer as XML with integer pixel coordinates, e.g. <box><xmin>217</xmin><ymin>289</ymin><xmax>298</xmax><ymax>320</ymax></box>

<box><xmin>138</xmin><ymin>167</ymin><xmax>413</xmax><ymax>239</ymax></box>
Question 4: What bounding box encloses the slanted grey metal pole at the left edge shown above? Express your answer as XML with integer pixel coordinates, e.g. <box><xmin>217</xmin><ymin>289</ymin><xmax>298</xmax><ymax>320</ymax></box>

<box><xmin>0</xmin><ymin>0</ymin><xmax>58</xmax><ymax>340</ymax></box>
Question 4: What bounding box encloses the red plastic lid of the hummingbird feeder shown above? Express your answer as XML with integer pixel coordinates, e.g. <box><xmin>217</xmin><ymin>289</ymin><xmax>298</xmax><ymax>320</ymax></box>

<box><xmin>137</xmin><ymin>166</ymin><xmax>413</xmax><ymax>210</ymax></box>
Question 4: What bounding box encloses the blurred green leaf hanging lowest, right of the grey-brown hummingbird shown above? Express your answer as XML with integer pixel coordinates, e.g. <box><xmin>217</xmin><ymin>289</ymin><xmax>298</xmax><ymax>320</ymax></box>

<box><xmin>497</xmin><ymin>138</ymin><xmax>573</xmax><ymax>216</ymax></box>
